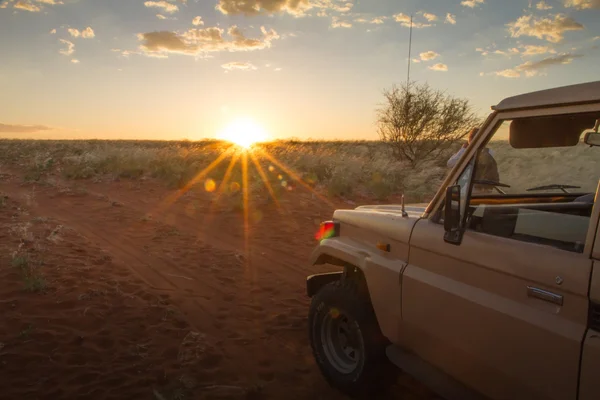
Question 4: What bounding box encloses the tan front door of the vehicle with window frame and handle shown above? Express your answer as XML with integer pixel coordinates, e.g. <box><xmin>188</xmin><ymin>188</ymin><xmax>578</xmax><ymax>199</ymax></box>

<box><xmin>400</xmin><ymin>105</ymin><xmax>600</xmax><ymax>400</ymax></box>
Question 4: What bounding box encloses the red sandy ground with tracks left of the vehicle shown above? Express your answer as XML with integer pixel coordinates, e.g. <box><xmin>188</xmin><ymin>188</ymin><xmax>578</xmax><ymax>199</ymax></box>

<box><xmin>0</xmin><ymin>170</ymin><xmax>433</xmax><ymax>400</ymax></box>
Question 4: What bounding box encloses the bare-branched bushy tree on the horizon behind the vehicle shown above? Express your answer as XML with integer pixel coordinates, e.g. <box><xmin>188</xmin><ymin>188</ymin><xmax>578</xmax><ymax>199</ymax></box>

<box><xmin>377</xmin><ymin>83</ymin><xmax>480</xmax><ymax>167</ymax></box>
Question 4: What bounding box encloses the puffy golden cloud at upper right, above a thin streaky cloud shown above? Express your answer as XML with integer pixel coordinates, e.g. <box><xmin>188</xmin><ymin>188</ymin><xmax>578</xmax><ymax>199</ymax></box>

<box><xmin>507</xmin><ymin>14</ymin><xmax>584</xmax><ymax>43</ymax></box>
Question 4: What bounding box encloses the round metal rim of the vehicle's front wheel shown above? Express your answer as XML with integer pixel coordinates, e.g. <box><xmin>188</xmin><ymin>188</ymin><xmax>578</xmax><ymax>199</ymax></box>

<box><xmin>321</xmin><ymin>312</ymin><xmax>364</xmax><ymax>374</ymax></box>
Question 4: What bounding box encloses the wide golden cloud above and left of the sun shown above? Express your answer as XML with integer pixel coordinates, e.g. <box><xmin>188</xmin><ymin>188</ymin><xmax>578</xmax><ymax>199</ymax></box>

<box><xmin>138</xmin><ymin>26</ymin><xmax>280</xmax><ymax>57</ymax></box>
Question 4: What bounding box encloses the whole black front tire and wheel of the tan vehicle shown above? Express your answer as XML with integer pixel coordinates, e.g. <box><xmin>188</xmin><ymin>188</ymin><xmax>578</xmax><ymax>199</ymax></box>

<box><xmin>308</xmin><ymin>279</ymin><xmax>397</xmax><ymax>398</ymax></box>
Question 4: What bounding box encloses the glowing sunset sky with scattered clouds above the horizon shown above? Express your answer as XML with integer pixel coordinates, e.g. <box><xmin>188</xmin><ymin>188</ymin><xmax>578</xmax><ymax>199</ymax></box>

<box><xmin>0</xmin><ymin>0</ymin><xmax>600</xmax><ymax>140</ymax></box>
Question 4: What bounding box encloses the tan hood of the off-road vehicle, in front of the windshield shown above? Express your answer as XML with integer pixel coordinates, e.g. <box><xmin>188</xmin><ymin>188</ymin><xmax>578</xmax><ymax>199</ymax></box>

<box><xmin>333</xmin><ymin>204</ymin><xmax>427</xmax><ymax>243</ymax></box>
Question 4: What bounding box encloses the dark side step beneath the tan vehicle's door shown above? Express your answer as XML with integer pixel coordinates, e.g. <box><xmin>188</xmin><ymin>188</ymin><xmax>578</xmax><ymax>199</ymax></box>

<box><xmin>386</xmin><ymin>345</ymin><xmax>486</xmax><ymax>400</ymax></box>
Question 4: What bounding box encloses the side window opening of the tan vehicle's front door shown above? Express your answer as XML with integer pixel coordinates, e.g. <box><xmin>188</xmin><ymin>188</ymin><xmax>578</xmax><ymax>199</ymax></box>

<box><xmin>457</xmin><ymin>113</ymin><xmax>600</xmax><ymax>252</ymax></box>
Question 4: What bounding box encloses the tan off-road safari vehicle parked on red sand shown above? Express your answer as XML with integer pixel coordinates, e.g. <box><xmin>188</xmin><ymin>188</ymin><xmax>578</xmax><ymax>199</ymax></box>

<box><xmin>306</xmin><ymin>81</ymin><xmax>600</xmax><ymax>400</ymax></box>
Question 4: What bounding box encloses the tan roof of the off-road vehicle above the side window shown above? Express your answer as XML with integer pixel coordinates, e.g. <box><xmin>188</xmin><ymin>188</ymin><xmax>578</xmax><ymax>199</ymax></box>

<box><xmin>492</xmin><ymin>81</ymin><xmax>600</xmax><ymax>111</ymax></box>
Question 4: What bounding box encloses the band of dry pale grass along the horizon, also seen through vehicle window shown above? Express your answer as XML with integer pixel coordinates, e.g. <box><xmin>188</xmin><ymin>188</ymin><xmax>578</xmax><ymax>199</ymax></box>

<box><xmin>0</xmin><ymin>140</ymin><xmax>600</xmax><ymax>204</ymax></box>
